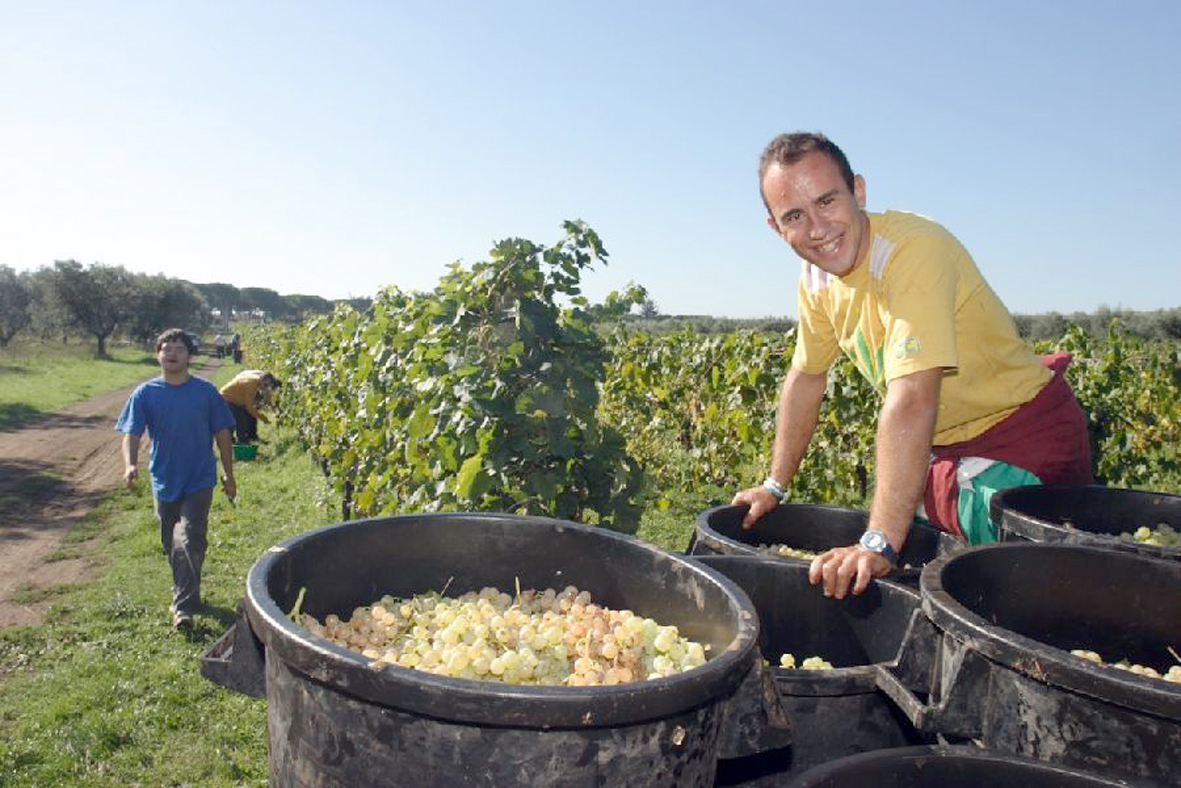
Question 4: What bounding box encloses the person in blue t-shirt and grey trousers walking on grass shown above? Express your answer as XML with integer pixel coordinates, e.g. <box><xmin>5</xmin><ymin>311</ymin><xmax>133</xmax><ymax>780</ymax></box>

<box><xmin>115</xmin><ymin>328</ymin><xmax>237</xmax><ymax>629</ymax></box>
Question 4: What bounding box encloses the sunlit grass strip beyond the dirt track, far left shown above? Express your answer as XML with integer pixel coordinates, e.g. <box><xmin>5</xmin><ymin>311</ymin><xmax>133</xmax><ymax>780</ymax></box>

<box><xmin>0</xmin><ymin>340</ymin><xmax>158</xmax><ymax>431</ymax></box>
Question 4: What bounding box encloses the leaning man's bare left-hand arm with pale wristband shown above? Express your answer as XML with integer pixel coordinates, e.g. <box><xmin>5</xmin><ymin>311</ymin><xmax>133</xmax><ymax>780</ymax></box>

<box><xmin>733</xmin><ymin>366</ymin><xmax>828</xmax><ymax>528</ymax></box>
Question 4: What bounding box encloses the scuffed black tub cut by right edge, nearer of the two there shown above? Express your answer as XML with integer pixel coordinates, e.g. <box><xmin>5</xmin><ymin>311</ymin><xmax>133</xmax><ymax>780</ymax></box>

<box><xmin>879</xmin><ymin>542</ymin><xmax>1181</xmax><ymax>784</ymax></box>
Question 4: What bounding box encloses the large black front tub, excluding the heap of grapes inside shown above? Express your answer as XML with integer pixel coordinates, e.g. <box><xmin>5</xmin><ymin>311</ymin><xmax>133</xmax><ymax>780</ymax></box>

<box><xmin>204</xmin><ymin>514</ymin><xmax>758</xmax><ymax>788</ymax></box>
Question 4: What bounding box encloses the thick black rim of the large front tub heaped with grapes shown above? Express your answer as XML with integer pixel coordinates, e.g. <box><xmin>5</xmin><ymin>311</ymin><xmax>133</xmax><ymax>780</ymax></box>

<box><xmin>247</xmin><ymin>513</ymin><xmax>758</xmax><ymax>729</ymax></box>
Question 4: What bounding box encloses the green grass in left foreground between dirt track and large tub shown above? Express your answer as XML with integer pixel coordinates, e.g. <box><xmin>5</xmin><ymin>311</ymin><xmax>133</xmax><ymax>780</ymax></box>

<box><xmin>0</xmin><ymin>427</ymin><xmax>339</xmax><ymax>787</ymax></box>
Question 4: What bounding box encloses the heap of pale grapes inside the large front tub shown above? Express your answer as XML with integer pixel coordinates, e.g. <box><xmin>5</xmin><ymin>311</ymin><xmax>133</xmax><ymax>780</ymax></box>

<box><xmin>300</xmin><ymin>586</ymin><xmax>709</xmax><ymax>686</ymax></box>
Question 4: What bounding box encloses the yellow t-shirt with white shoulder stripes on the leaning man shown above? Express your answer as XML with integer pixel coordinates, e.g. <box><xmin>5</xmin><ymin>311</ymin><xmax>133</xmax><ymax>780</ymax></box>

<box><xmin>791</xmin><ymin>211</ymin><xmax>1050</xmax><ymax>445</ymax></box>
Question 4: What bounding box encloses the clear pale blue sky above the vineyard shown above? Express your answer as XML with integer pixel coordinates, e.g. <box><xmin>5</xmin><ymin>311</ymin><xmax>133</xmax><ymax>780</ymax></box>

<box><xmin>0</xmin><ymin>0</ymin><xmax>1181</xmax><ymax>318</ymax></box>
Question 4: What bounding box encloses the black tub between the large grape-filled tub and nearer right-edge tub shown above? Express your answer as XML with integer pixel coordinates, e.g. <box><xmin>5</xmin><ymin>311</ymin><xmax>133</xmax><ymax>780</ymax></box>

<box><xmin>694</xmin><ymin>555</ymin><xmax>929</xmax><ymax>786</ymax></box>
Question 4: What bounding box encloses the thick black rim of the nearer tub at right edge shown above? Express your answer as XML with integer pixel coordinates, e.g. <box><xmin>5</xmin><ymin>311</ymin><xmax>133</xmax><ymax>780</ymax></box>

<box><xmin>921</xmin><ymin>542</ymin><xmax>1181</xmax><ymax>719</ymax></box>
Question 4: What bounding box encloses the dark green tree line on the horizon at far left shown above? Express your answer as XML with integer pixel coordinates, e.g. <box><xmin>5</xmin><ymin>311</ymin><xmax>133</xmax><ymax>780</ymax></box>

<box><xmin>0</xmin><ymin>260</ymin><xmax>368</xmax><ymax>357</ymax></box>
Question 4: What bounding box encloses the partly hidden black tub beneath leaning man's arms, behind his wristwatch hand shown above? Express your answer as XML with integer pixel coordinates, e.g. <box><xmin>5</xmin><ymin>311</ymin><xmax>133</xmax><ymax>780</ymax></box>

<box><xmin>689</xmin><ymin>503</ymin><xmax>964</xmax><ymax>588</ymax></box>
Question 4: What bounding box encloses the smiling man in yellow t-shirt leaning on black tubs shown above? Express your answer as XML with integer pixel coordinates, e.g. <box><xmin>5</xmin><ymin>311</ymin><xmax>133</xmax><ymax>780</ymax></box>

<box><xmin>733</xmin><ymin>132</ymin><xmax>1092</xmax><ymax>599</ymax></box>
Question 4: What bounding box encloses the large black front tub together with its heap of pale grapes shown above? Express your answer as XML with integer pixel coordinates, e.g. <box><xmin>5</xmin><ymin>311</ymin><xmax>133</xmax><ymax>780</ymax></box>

<box><xmin>212</xmin><ymin>513</ymin><xmax>762</xmax><ymax>788</ymax></box>
